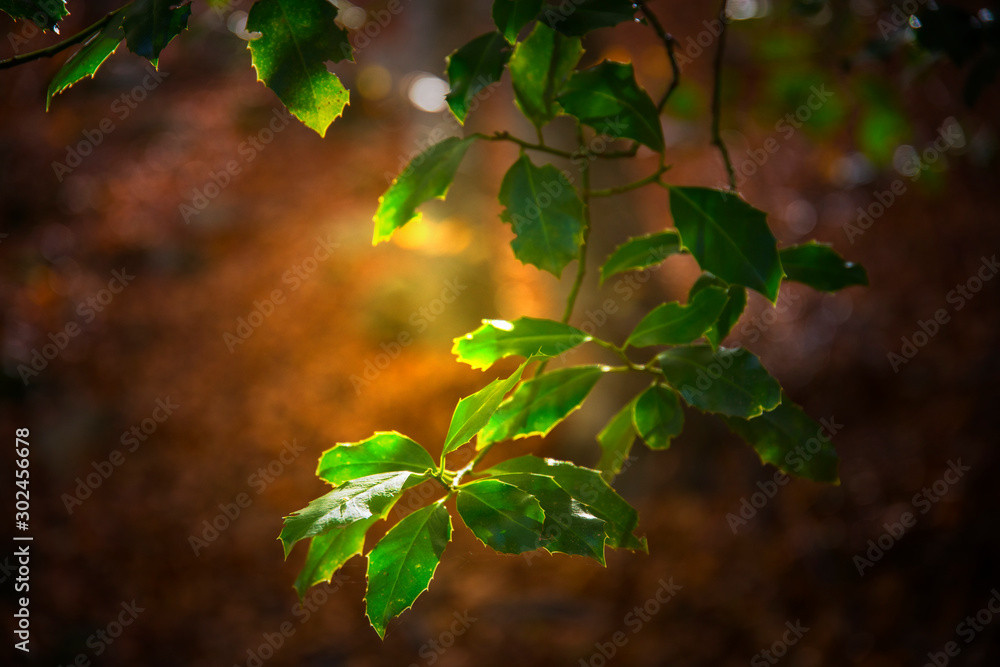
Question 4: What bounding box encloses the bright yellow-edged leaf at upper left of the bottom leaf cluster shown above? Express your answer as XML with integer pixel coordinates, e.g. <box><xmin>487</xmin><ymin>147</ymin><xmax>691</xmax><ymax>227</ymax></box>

<box><xmin>316</xmin><ymin>431</ymin><xmax>435</xmax><ymax>486</ymax></box>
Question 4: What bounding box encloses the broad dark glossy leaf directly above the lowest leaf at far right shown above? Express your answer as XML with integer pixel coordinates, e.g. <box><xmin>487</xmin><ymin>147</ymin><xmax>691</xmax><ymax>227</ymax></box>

<box><xmin>657</xmin><ymin>345</ymin><xmax>781</xmax><ymax>419</ymax></box>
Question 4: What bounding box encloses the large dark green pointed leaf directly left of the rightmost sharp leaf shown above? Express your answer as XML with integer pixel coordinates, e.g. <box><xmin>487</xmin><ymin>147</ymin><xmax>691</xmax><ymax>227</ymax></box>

<box><xmin>670</xmin><ymin>186</ymin><xmax>784</xmax><ymax>303</ymax></box>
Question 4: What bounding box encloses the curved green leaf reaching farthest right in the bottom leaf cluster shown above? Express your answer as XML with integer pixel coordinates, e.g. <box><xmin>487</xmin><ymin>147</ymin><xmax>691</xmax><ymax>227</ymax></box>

<box><xmin>484</xmin><ymin>455</ymin><xmax>647</xmax><ymax>551</ymax></box>
